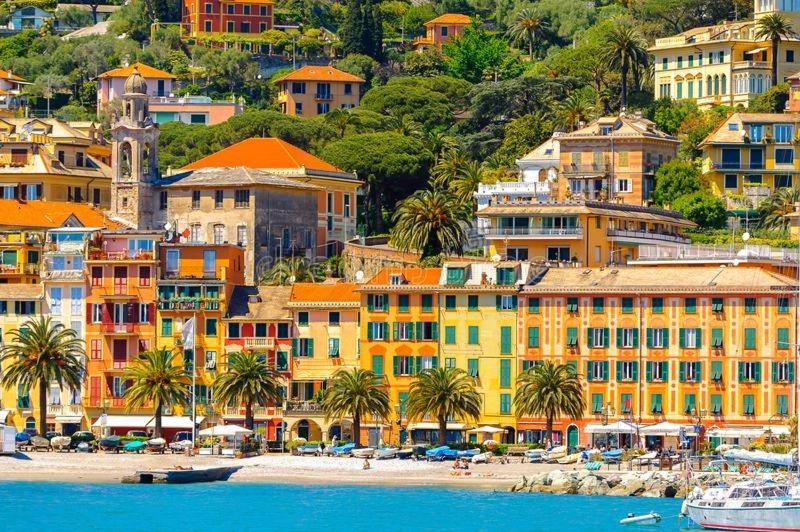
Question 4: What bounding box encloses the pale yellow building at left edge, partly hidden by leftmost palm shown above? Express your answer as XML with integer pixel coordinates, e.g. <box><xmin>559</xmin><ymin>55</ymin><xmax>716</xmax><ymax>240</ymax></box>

<box><xmin>0</xmin><ymin>283</ymin><xmax>47</xmax><ymax>430</ymax></box>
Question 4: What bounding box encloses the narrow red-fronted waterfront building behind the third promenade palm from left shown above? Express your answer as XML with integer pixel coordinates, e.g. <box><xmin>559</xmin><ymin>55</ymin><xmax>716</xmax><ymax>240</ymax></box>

<box><xmin>220</xmin><ymin>286</ymin><xmax>292</xmax><ymax>441</ymax></box>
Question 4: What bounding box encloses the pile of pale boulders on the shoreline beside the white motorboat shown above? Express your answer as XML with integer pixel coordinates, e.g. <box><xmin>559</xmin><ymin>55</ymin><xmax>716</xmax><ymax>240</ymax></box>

<box><xmin>511</xmin><ymin>469</ymin><xmax>780</xmax><ymax>498</ymax></box>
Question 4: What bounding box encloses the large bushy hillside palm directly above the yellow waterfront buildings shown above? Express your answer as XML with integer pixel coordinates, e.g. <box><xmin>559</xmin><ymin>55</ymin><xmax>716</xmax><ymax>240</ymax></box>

<box><xmin>390</xmin><ymin>188</ymin><xmax>472</xmax><ymax>258</ymax></box>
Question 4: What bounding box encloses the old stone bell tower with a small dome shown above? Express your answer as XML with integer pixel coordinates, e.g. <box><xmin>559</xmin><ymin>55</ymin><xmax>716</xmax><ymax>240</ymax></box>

<box><xmin>111</xmin><ymin>66</ymin><xmax>159</xmax><ymax>229</ymax></box>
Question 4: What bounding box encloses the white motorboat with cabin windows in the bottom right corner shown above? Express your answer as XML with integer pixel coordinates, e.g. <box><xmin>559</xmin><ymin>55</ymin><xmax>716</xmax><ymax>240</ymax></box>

<box><xmin>681</xmin><ymin>480</ymin><xmax>800</xmax><ymax>532</ymax></box>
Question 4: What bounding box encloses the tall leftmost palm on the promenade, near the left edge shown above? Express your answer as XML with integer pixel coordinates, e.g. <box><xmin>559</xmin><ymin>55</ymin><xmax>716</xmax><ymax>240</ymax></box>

<box><xmin>0</xmin><ymin>316</ymin><xmax>86</xmax><ymax>434</ymax></box>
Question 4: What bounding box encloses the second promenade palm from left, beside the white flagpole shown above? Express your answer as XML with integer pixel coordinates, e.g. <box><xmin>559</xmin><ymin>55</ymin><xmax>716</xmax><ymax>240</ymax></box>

<box><xmin>124</xmin><ymin>349</ymin><xmax>188</xmax><ymax>438</ymax></box>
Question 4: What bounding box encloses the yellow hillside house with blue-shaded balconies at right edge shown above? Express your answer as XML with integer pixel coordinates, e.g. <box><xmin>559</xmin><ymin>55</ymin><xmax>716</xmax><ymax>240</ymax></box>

<box><xmin>701</xmin><ymin>113</ymin><xmax>800</xmax><ymax>208</ymax></box>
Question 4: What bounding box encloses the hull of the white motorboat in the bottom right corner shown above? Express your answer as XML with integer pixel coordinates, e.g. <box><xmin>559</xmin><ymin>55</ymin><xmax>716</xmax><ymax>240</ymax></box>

<box><xmin>687</xmin><ymin>504</ymin><xmax>800</xmax><ymax>532</ymax></box>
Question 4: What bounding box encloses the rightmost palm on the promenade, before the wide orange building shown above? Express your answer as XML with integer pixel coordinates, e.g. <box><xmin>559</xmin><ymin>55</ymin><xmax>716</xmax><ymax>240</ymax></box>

<box><xmin>514</xmin><ymin>361</ymin><xmax>586</xmax><ymax>440</ymax></box>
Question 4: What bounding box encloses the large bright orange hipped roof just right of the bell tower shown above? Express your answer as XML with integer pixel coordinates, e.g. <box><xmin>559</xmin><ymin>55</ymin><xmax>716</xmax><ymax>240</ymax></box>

<box><xmin>183</xmin><ymin>137</ymin><xmax>342</xmax><ymax>172</ymax></box>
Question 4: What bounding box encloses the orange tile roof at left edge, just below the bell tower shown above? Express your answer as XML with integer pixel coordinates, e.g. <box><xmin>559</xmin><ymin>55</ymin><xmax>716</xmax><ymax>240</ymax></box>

<box><xmin>0</xmin><ymin>199</ymin><xmax>123</xmax><ymax>229</ymax></box>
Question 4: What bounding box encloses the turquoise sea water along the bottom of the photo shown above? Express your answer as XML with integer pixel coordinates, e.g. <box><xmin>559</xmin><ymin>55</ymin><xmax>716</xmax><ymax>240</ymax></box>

<box><xmin>0</xmin><ymin>482</ymin><xmax>683</xmax><ymax>532</ymax></box>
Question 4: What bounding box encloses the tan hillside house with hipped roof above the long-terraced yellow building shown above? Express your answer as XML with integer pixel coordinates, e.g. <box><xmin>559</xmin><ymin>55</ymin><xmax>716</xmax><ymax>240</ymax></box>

<box><xmin>557</xmin><ymin>113</ymin><xmax>679</xmax><ymax>205</ymax></box>
